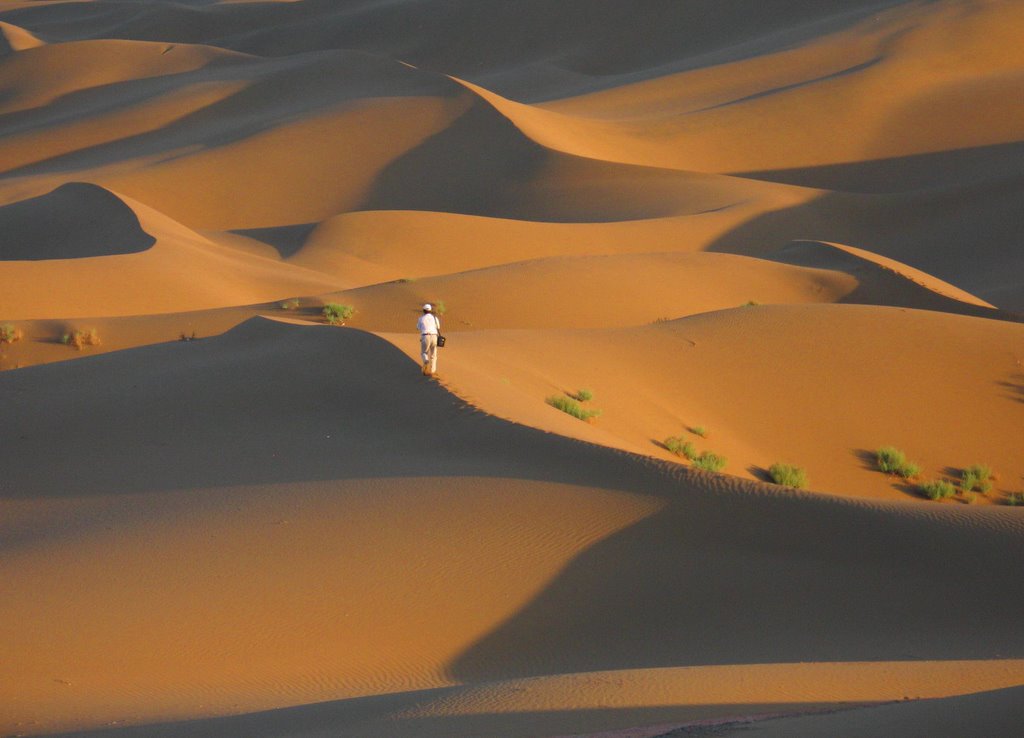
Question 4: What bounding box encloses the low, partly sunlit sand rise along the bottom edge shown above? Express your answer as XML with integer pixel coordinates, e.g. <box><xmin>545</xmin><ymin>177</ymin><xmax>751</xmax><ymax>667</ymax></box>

<box><xmin>37</xmin><ymin>660</ymin><xmax>1024</xmax><ymax>738</ymax></box>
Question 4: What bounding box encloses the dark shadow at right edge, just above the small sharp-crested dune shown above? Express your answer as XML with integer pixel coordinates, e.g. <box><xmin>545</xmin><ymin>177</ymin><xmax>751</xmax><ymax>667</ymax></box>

<box><xmin>708</xmin><ymin>142</ymin><xmax>1024</xmax><ymax>311</ymax></box>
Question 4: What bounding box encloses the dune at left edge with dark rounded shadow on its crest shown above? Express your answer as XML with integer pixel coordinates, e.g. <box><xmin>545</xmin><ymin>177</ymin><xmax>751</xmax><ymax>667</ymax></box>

<box><xmin>0</xmin><ymin>183</ymin><xmax>339</xmax><ymax>319</ymax></box>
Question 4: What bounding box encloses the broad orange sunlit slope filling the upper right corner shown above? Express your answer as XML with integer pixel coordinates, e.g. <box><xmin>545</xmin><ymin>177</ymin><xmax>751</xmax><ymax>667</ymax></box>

<box><xmin>528</xmin><ymin>2</ymin><xmax>1024</xmax><ymax>174</ymax></box>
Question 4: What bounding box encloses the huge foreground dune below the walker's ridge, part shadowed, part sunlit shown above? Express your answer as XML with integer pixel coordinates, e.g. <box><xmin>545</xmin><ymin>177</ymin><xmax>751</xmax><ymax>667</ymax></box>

<box><xmin>0</xmin><ymin>320</ymin><xmax>1024</xmax><ymax>735</ymax></box>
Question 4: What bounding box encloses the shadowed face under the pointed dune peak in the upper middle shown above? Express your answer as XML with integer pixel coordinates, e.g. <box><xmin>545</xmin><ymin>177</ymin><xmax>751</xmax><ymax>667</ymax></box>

<box><xmin>359</xmin><ymin>91</ymin><xmax>753</xmax><ymax>223</ymax></box>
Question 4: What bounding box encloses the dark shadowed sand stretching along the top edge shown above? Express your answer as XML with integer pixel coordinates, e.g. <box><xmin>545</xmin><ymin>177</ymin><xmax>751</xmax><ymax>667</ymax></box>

<box><xmin>5</xmin><ymin>0</ymin><xmax>904</xmax><ymax>101</ymax></box>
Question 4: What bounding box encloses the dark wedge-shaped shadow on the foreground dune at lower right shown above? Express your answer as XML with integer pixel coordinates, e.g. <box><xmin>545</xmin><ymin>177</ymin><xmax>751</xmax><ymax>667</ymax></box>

<box><xmin>450</xmin><ymin>468</ymin><xmax>1024</xmax><ymax>682</ymax></box>
